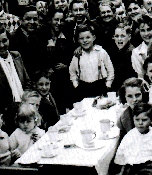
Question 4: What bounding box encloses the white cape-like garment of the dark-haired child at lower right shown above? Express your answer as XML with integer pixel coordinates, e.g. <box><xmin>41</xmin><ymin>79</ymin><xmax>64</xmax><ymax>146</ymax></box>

<box><xmin>114</xmin><ymin>127</ymin><xmax>152</xmax><ymax>165</ymax></box>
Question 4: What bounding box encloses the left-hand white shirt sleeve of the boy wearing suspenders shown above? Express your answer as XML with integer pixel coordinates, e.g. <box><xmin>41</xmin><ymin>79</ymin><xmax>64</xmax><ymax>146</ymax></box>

<box><xmin>69</xmin><ymin>56</ymin><xmax>79</xmax><ymax>83</ymax></box>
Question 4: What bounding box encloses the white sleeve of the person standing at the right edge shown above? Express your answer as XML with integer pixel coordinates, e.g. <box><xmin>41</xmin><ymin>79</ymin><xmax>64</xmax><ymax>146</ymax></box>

<box><xmin>131</xmin><ymin>49</ymin><xmax>144</xmax><ymax>78</ymax></box>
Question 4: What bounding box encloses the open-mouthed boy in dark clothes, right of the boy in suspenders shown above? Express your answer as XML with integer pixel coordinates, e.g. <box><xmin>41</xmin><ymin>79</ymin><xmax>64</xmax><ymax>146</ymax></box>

<box><xmin>110</xmin><ymin>23</ymin><xmax>136</xmax><ymax>92</ymax></box>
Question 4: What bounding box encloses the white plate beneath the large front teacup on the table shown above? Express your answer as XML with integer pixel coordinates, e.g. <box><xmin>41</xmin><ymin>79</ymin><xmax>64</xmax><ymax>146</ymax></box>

<box><xmin>76</xmin><ymin>139</ymin><xmax>108</xmax><ymax>150</ymax></box>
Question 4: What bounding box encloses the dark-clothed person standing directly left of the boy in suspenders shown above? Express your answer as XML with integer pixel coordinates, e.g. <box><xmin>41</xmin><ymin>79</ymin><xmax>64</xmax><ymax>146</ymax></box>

<box><xmin>47</xmin><ymin>8</ymin><xmax>73</xmax><ymax>114</ymax></box>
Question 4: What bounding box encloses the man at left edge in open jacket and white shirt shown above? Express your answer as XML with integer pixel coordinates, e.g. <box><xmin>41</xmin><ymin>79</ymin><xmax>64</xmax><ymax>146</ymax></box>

<box><xmin>0</xmin><ymin>28</ymin><xmax>30</xmax><ymax>111</ymax></box>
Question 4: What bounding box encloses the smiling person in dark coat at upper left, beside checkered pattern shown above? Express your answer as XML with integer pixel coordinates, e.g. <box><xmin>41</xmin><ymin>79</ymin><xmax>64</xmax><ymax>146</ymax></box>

<box><xmin>10</xmin><ymin>7</ymin><xmax>47</xmax><ymax>76</ymax></box>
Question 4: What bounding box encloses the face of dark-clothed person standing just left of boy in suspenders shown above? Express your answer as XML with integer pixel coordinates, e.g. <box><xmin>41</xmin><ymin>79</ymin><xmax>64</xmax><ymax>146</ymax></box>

<box><xmin>52</xmin><ymin>12</ymin><xmax>65</xmax><ymax>32</ymax></box>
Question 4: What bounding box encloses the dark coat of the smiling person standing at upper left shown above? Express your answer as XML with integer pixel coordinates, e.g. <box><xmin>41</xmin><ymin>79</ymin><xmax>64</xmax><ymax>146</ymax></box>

<box><xmin>9</xmin><ymin>26</ymin><xmax>47</xmax><ymax>78</ymax></box>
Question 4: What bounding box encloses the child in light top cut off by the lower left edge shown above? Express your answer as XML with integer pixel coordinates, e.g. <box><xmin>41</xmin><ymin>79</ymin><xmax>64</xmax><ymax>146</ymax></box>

<box><xmin>0</xmin><ymin>115</ymin><xmax>11</xmax><ymax>167</ymax></box>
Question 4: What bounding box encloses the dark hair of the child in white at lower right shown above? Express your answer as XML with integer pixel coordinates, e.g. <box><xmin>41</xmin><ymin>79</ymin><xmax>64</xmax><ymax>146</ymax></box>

<box><xmin>133</xmin><ymin>102</ymin><xmax>152</xmax><ymax>120</ymax></box>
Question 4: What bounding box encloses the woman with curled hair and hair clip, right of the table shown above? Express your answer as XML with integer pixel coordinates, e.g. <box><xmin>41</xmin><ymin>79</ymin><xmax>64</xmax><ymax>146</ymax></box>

<box><xmin>117</xmin><ymin>77</ymin><xmax>149</xmax><ymax>140</ymax></box>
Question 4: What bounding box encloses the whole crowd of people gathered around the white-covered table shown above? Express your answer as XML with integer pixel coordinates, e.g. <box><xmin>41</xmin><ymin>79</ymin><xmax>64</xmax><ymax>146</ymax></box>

<box><xmin>0</xmin><ymin>0</ymin><xmax>152</xmax><ymax>175</ymax></box>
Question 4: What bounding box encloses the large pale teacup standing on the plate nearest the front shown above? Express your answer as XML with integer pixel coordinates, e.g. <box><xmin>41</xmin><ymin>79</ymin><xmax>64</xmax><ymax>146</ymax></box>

<box><xmin>80</xmin><ymin>129</ymin><xmax>96</xmax><ymax>148</ymax></box>
